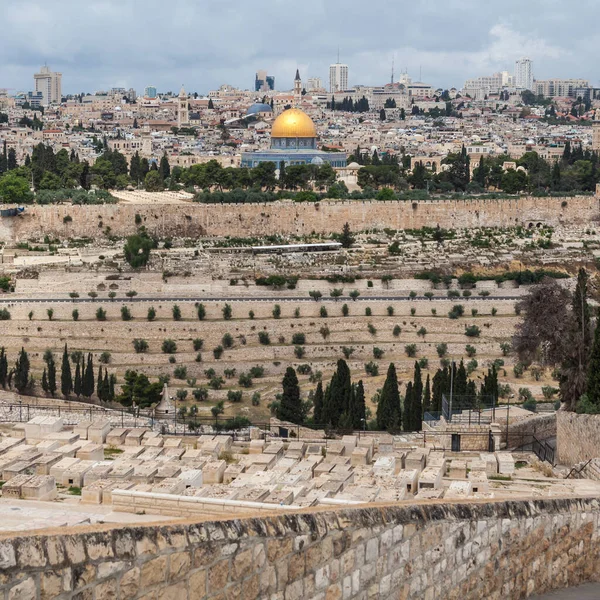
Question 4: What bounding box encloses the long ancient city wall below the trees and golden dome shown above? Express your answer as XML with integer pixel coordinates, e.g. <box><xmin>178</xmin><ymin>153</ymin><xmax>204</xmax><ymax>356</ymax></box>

<box><xmin>0</xmin><ymin>196</ymin><xmax>600</xmax><ymax>242</ymax></box>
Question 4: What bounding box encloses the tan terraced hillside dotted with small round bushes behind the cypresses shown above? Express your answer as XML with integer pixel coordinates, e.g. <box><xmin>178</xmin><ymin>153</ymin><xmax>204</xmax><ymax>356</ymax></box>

<box><xmin>0</xmin><ymin>292</ymin><xmax>551</xmax><ymax>422</ymax></box>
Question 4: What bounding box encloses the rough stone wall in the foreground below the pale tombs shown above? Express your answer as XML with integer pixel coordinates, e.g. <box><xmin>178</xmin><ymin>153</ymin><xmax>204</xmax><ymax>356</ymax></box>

<box><xmin>0</xmin><ymin>499</ymin><xmax>600</xmax><ymax>600</ymax></box>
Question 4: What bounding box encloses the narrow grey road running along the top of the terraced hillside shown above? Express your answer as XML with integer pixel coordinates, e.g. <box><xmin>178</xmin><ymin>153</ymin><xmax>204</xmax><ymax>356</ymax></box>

<box><xmin>0</xmin><ymin>296</ymin><xmax>523</xmax><ymax>304</ymax></box>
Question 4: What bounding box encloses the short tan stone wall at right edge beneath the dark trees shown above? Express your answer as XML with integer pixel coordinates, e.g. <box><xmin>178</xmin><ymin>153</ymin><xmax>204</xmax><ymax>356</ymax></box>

<box><xmin>556</xmin><ymin>412</ymin><xmax>600</xmax><ymax>467</ymax></box>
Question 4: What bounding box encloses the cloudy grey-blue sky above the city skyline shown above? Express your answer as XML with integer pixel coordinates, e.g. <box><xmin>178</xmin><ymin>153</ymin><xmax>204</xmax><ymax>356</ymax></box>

<box><xmin>0</xmin><ymin>0</ymin><xmax>600</xmax><ymax>93</ymax></box>
